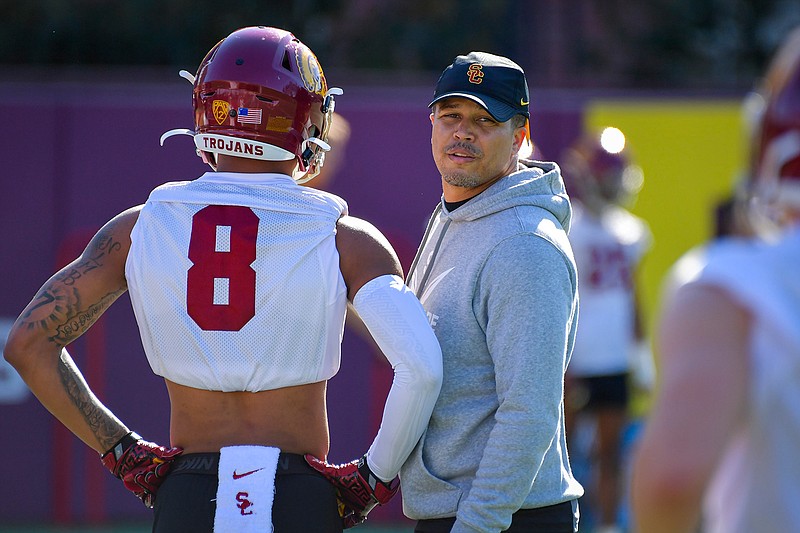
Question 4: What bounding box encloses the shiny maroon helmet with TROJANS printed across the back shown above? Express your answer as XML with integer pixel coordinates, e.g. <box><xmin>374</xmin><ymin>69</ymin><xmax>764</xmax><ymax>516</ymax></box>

<box><xmin>161</xmin><ymin>26</ymin><xmax>342</xmax><ymax>183</ymax></box>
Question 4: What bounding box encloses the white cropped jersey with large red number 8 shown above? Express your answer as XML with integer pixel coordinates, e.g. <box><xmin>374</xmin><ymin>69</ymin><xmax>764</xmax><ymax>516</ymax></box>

<box><xmin>125</xmin><ymin>172</ymin><xmax>347</xmax><ymax>391</ymax></box>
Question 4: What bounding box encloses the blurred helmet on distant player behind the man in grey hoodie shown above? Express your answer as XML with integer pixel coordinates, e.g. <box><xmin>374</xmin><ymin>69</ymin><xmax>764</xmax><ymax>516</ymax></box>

<box><xmin>562</xmin><ymin>127</ymin><xmax>643</xmax><ymax>207</ymax></box>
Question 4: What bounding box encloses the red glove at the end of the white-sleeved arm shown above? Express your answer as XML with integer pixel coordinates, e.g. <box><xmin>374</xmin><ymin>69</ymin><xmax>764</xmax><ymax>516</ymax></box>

<box><xmin>305</xmin><ymin>454</ymin><xmax>400</xmax><ymax>529</ymax></box>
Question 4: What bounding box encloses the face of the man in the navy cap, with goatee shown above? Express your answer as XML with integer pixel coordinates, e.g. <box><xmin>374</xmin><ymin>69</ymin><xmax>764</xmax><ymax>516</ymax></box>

<box><xmin>431</xmin><ymin>97</ymin><xmax>525</xmax><ymax>201</ymax></box>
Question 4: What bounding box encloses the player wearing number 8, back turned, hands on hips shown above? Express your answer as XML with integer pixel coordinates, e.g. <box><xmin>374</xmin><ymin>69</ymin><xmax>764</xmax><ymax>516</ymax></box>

<box><xmin>5</xmin><ymin>26</ymin><xmax>441</xmax><ymax>533</ymax></box>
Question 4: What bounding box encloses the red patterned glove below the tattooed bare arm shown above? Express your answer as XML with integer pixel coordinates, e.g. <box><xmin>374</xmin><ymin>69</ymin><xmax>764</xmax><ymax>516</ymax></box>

<box><xmin>100</xmin><ymin>432</ymin><xmax>183</xmax><ymax>509</ymax></box>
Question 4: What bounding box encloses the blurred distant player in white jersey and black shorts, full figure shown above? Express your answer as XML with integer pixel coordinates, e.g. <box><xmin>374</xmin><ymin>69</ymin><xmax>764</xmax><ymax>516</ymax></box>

<box><xmin>562</xmin><ymin>128</ymin><xmax>652</xmax><ymax>533</ymax></box>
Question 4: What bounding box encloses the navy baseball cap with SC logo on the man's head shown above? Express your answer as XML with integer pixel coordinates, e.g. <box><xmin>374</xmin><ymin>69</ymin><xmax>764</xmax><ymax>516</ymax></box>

<box><xmin>428</xmin><ymin>52</ymin><xmax>531</xmax><ymax>122</ymax></box>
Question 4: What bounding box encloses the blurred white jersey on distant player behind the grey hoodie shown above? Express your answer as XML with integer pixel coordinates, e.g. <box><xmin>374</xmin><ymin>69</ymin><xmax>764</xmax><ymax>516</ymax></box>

<box><xmin>569</xmin><ymin>202</ymin><xmax>652</xmax><ymax>376</ymax></box>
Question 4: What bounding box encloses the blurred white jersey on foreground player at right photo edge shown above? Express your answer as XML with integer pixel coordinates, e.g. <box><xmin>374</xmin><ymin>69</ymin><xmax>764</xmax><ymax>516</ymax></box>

<box><xmin>698</xmin><ymin>229</ymin><xmax>800</xmax><ymax>533</ymax></box>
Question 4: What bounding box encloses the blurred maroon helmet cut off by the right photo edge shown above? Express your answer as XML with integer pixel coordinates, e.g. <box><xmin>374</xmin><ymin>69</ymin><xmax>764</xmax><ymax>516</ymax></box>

<box><xmin>748</xmin><ymin>29</ymin><xmax>800</xmax><ymax>214</ymax></box>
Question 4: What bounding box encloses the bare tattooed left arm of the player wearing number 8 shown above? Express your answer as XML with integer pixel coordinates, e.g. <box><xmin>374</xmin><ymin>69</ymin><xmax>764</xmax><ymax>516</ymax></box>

<box><xmin>5</xmin><ymin>208</ymin><xmax>139</xmax><ymax>453</ymax></box>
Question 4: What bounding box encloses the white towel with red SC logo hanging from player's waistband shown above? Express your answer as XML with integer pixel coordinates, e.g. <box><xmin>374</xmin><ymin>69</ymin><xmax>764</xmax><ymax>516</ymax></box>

<box><xmin>214</xmin><ymin>446</ymin><xmax>280</xmax><ymax>533</ymax></box>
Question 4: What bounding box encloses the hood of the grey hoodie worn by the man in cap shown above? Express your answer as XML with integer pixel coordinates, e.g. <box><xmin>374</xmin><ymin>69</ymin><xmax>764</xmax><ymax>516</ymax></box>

<box><xmin>441</xmin><ymin>160</ymin><xmax>572</xmax><ymax>230</ymax></box>
